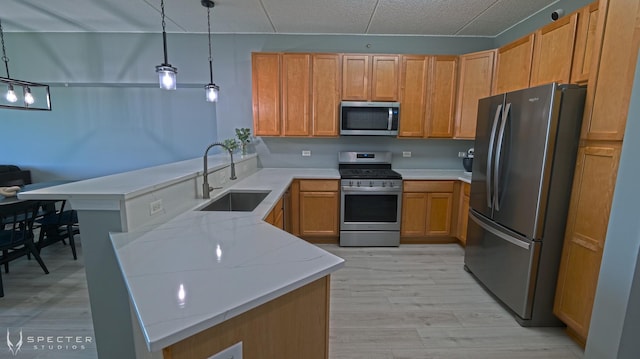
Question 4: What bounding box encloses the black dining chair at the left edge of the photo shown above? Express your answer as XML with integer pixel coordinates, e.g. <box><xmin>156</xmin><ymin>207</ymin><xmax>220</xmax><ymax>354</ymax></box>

<box><xmin>0</xmin><ymin>201</ymin><xmax>49</xmax><ymax>297</ymax></box>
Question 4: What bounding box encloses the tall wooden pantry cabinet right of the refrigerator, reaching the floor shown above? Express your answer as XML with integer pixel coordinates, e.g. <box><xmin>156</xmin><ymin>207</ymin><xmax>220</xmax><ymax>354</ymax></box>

<box><xmin>554</xmin><ymin>0</ymin><xmax>640</xmax><ymax>345</ymax></box>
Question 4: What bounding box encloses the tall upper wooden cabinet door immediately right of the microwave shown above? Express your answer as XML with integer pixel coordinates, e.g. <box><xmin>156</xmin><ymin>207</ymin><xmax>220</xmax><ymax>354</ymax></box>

<box><xmin>398</xmin><ymin>56</ymin><xmax>429</xmax><ymax>138</ymax></box>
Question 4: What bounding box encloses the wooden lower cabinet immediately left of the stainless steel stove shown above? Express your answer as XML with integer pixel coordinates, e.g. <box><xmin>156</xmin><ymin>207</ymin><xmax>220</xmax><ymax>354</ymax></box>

<box><xmin>291</xmin><ymin>180</ymin><xmax>340</xmax><ymax>243</ymax></box>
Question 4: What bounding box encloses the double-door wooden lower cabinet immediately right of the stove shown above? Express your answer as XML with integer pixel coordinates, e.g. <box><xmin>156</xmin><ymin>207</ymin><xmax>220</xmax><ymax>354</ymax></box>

<box><xmin>400</xmin><ymin>181</ymin><xmax>455</xmax><ymax>244</ymax></box>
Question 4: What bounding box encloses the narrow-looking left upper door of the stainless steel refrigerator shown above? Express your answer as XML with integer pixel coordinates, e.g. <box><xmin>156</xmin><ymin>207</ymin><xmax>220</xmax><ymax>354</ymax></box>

<box><xmin>469</xmin><ymin>95</ymin><xmax>504</xmax><ymax>217</ymax></box>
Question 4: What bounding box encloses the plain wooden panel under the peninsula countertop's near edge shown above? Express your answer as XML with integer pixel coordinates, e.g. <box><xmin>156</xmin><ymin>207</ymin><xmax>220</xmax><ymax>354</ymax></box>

<box><xmin>162</xmin><ymin>276</ymin><xmax>330</xmax><ymax>359</ymax></box>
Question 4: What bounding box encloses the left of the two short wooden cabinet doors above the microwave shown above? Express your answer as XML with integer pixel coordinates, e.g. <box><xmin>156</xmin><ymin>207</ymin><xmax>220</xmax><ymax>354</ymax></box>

<box><xmin>342</xmin><ymin>55</ymin><xmax>370</xmax><ymax>101</ymax></box>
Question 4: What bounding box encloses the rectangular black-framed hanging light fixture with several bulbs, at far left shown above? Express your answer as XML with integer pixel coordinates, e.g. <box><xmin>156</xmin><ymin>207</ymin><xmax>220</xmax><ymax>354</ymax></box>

<box><xmin>0</xmin><ymin>20</ymin><xmax>51</xmax><ymax>111</ymax></box>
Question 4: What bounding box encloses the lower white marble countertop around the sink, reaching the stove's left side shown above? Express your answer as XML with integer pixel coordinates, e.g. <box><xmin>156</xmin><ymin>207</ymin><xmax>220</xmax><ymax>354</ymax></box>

<box><xmin>111</xmin><ymin>169</ymin><xmax>344</xmax><ymax>352</ymax></box>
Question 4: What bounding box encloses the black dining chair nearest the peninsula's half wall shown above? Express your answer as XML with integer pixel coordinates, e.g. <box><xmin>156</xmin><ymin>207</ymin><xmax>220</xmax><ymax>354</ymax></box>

<box><xmin>36</xmin><ymin>200</ymin><xmax>80</xmax><ymax>260</ymax></box>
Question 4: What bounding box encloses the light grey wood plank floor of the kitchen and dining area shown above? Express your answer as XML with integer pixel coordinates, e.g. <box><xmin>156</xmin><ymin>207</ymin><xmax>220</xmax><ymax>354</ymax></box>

<box><xmin>0</xmin><ymin>241</ymin><xmax>582</xmax><ymax>359</ymax></box>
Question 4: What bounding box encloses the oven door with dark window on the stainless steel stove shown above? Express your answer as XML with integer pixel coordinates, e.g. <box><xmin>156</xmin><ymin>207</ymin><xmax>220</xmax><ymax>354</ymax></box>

<box><xmin>340</xmin><ymin>186</ymin><xmax>402</xmax><ymax>231</ymax></box>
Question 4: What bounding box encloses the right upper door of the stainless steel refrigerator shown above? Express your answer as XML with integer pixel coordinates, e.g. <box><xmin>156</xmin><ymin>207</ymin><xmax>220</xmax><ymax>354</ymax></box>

<box><xmin>492</xmin><ymin>84</ymin><xmax>561</xmax><ymax>240</ymax></box>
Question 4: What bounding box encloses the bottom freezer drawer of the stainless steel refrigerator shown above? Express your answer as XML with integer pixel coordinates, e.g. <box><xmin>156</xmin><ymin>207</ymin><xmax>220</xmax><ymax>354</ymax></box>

<box><xmin>464</xmin><ymin>210</ymin><xmax>541</xmax><ymax>320</ymax></box>
